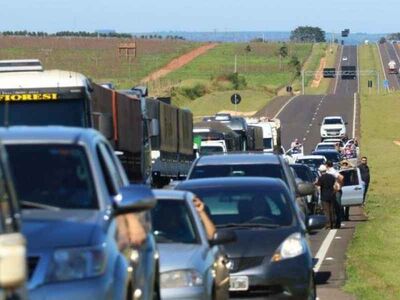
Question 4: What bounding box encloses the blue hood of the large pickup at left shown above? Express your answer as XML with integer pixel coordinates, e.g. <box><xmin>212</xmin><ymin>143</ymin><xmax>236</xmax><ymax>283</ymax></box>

<box><xmin>22</xmin><ymin>209</ymin><xmax>104</xmax><ymax>252</ymax></box>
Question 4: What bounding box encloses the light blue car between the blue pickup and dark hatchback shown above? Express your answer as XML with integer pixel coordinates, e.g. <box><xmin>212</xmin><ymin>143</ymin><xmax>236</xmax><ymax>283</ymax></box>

<box><xmin>151</xmin><ymin>190</ymin><xmax>235</xmax><ymax>300</ymax></box>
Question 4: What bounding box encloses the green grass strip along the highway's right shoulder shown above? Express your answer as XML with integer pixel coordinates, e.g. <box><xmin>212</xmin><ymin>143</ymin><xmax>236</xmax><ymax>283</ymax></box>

<box><xmin>345</xmin><ymin>45</ymin><xmax>400</xmax><ymax>300</ymax></box>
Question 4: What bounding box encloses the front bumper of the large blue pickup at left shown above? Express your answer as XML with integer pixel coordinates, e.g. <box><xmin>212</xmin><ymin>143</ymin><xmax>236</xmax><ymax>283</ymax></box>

<box><xmin>29</xmin><ymin>276</ymin><xmax>116</xmax><ymax>300</ymax></box>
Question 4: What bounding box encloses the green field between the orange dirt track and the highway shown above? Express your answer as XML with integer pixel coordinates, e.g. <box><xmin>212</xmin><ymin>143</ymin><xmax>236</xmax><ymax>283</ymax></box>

<box><xmin>159</xmin><ymin>43</ymin><xmax>312</xmax><ymax>116</ymax></box>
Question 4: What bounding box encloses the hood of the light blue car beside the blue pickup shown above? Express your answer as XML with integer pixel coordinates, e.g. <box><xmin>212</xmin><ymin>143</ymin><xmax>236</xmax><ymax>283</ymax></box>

<box><xmin>158</xmin><ymin>243</ymin><xmax>207</xmax><ymax>273</ymax></box>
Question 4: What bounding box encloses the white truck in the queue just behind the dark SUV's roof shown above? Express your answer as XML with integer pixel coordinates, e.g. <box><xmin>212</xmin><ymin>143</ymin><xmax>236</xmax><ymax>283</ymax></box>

<box><xmin>246</xmin><ymin>117</ymin><xmax>281</xmax><ymax>152</ymax></box>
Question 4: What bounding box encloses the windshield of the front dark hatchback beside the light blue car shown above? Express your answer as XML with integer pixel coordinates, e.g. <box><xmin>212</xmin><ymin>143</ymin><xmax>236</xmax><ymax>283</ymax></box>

<box><xmin>183</xmin><ymin>186</ymin><xmax>293</xmax><ymax>227</ymax></box>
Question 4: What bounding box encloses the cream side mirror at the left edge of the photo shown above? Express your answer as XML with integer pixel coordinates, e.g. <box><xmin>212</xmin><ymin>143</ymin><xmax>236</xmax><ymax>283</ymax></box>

<box><xmin>0</xmin><ymin>233</ymin><xmax>27</xmax><ymax>289</ymax></box>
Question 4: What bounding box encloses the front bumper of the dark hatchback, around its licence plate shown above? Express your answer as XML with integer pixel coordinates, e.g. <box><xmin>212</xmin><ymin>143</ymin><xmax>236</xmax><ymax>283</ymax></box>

<box><xmin>230</xmin><ymin>255</ymin><xmax>312</xmax><ymax>299</ymax></box>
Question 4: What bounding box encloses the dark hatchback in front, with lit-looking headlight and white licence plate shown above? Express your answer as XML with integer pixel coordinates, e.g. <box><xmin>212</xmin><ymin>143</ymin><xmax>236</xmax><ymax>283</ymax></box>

<box><xmin>177</xmin><ymin>177</ymin><xmax>326</xmax><ymax>299</ymax></box>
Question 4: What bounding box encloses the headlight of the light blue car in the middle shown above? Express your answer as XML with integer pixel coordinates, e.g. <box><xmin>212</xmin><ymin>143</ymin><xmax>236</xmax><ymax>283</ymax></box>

<box><xmin>160</xmin><ymin>270</ymin><xmax>203</xmax><ymax>289</ymax></box>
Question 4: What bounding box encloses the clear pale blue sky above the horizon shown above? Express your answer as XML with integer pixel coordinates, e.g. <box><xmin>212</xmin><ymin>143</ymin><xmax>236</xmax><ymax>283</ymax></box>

<box><xmin>0</xmin><ymin>0</ymin><xmax>400</xmax><ymax>33</ymax></box>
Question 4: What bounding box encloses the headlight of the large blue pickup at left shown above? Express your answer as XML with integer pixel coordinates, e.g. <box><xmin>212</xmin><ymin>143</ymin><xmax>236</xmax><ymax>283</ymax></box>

<box><xmin>46</xmin><ymin>246</ymin><xmax>107</xmax><ymax>282</ymax></box>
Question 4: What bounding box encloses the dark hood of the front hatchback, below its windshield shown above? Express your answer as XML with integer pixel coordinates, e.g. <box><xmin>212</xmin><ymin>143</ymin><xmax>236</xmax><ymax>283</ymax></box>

<box><xmin>224</xmin><ymin>226</ymin><xmax>298</xmax><ymax>258</ymax></box>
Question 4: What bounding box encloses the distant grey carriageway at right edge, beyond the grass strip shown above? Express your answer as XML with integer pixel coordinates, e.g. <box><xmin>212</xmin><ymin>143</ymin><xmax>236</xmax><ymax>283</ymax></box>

<box><xmin>378</xmin><ymin>43</ymin><xmax>400</xmax><ymax>90</ymax></box>
